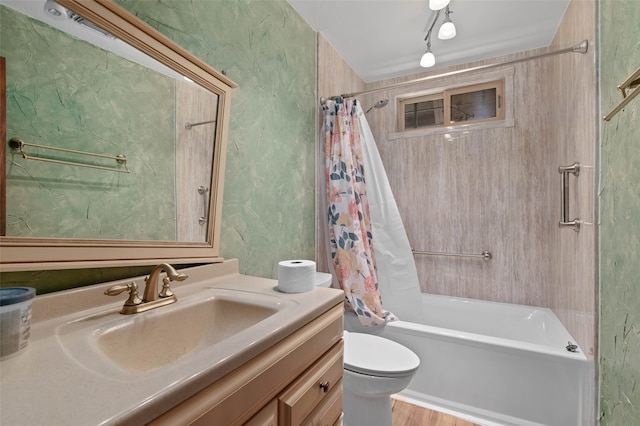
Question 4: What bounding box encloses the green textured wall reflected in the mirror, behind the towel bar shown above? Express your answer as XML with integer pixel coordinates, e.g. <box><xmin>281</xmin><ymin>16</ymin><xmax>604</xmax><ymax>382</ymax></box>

<box><xmin>0</xmin><ymin>6</ymin><xmax>175</xmax><ymax>240</ymax></box>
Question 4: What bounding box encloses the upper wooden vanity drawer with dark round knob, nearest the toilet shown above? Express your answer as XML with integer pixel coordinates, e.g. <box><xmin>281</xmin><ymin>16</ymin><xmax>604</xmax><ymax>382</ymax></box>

<box><xmin>278</xmin><ymin>340</ymin><xmax>343</xmax><ymax>426</ymax></box>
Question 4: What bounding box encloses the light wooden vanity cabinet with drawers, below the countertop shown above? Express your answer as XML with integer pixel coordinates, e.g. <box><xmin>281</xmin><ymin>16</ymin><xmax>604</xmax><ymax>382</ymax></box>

<box><xmin>149</xmin><ymin>303</ymin><xmax>343</xmax><ymax>426</ymax></box>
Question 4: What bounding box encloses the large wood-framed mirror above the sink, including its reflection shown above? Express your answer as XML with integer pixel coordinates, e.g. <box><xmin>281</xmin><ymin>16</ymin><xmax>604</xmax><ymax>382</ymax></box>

<box><xmin>0</xmin><ymin>0</ymin><xmax>237</xmax><ymax>271</ymax></box>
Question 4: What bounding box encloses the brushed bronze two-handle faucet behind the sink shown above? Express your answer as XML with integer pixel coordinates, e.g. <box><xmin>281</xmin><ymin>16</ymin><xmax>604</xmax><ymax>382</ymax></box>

<box><xmin>104</xmin><ymin>263</ymin><xmax>189</xmax><ymax>314</ymax></box>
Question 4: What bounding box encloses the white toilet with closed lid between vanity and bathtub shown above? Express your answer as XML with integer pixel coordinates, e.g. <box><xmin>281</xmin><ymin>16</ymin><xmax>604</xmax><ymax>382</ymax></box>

<box><xmin>316</xmin><ymin>272</ymin><xmax>420</xmax><ymax>426</ymax></box>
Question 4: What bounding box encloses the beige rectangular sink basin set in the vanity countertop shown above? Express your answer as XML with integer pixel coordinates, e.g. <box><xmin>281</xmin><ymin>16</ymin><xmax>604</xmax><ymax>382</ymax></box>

<box><xmin>57</xmin><ymin>288</ymin><xmax>295</xmax><ymax>373</ymax></box>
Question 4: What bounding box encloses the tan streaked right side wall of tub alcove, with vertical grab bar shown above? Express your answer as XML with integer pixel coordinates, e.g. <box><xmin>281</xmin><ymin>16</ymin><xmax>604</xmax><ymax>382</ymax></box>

<box><xmin>546</xmin><ymin>0</ymin><xmax>599</xmax><ymax>355</ymax></box>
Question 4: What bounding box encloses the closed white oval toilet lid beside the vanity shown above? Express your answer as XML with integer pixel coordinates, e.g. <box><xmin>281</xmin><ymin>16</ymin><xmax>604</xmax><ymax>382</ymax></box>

<box><xmin>343</xmin><ymin>332</ymin><xmax>420</xmax><ymax>377</ymax></box>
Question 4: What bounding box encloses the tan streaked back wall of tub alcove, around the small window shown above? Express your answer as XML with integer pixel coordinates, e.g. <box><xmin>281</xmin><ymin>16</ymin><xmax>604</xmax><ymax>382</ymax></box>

<box><xmin>363</xmin><ymin>58</ymin><xmax>558</xmax><ymax>306</ymax></box>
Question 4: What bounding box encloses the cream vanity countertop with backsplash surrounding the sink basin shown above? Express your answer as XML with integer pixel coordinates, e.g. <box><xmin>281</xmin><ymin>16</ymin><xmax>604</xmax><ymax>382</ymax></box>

<box><xmin>0</xmin><ymin>260</ymin><xmax>343</xmax><ymax>426</ymax></box>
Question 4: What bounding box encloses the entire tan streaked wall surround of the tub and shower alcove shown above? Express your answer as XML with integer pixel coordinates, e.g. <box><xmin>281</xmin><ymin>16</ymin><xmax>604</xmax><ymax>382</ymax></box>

<box><xmin>318</xmin><ymin>1</ymin><xmax>596</xmax><ymax>357</ymax></box>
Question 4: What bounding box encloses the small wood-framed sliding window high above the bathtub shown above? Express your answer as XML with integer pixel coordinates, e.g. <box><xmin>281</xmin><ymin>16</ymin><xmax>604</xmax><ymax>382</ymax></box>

<box><xmin>398</xmin><ymin>80</ymin><xmax>504</xmax><ymax>132</ymax></box>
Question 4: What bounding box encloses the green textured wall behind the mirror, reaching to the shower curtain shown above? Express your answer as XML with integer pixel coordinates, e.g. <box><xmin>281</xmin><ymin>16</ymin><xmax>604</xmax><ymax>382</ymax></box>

<box><xmin>0</xmin><ymin>0</ymin><xmax>316</xmax><ymax>292</ymax></box>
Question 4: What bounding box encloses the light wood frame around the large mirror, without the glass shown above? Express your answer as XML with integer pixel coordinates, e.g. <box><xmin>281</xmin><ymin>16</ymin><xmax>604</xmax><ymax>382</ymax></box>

<box><xmin>0</xmin><ymin>0</ymin><xmax>237</xmax><ymax>272</ymax></box>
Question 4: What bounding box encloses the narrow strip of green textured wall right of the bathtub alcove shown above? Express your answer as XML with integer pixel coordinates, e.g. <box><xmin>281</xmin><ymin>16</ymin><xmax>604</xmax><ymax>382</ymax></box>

<box><xmin>599</xmin><ymin>0</ymin><xmax>640</xmax><ymax>426</ymax></box>
